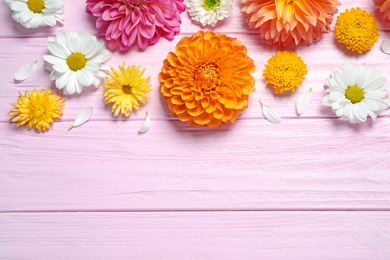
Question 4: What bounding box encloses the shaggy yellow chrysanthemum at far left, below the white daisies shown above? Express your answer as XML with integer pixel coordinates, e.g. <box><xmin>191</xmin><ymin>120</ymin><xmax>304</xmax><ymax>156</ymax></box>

<box><xmin>8</xmin><ymin>88</ymin><xmax>65</xmax><ymax>133</ymax></box>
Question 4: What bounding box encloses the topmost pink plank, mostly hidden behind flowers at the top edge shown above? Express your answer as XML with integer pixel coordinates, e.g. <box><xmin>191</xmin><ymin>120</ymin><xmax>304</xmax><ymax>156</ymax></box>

<box><xmin>0</xmin><ymin>0</ymin><xmax>390</xmax><ymax>38</ymax></box>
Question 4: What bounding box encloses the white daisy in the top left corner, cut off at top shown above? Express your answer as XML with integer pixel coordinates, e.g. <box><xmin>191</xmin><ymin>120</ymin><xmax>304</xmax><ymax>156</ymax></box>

<box><xmin>4</xmin><ymin>0</ymin><xmax>64</xmax><ymax>29</ymax></box>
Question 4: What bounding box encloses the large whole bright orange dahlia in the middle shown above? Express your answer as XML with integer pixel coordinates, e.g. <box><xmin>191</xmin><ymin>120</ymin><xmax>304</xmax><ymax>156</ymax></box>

<box><xmin>158</xmin><ymin>31</ymin><xmax>256</xmax><ymax>127</ymax></box>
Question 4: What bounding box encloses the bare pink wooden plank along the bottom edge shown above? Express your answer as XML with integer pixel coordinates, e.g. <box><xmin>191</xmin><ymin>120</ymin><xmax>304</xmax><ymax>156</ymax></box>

<box><xmin>0</xmin><ymin>212</ymin><xmax>390</xmax><ymax>260</ymax></box>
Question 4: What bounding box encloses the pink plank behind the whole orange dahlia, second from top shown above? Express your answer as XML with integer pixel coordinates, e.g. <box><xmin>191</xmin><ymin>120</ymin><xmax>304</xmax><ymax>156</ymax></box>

<box><xmin>0</xmin><ymin>31</ymin><xmax>390</xmax><ymax>121</ymax></box>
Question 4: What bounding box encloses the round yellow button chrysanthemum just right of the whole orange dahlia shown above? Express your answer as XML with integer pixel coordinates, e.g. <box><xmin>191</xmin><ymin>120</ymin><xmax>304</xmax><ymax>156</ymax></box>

<box><xmin>263</xmin><ymin>51</ymin><xmax>307</xmax><ymax>93</ymax></box>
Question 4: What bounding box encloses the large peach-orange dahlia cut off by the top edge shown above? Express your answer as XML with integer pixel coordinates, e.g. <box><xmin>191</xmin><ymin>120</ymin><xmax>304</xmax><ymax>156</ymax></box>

<box><xmin>240</xmin><ymin>0</ymin><xmax>340</xmax><ymax>46</ymax></box>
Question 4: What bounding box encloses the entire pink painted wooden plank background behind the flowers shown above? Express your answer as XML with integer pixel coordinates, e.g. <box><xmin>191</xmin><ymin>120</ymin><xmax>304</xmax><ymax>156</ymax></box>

<box><xmin>0</xmin><ymin>0</ymin><xmax>390</xmax><ymax>260</ymax></box>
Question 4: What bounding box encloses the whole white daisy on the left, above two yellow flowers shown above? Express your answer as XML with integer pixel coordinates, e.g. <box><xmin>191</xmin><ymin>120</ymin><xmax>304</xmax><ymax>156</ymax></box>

<box><xmin>43</xmin><ymin>30</ymin><xmax>112</xmax><ymax>95</ymax></box>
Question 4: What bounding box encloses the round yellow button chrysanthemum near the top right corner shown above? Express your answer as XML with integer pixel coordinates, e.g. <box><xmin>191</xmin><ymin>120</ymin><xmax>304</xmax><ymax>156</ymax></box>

<box><xmin>334</xmin><ymin>7</ymin><xmax>379</xmax><ymax>53</ymax></box>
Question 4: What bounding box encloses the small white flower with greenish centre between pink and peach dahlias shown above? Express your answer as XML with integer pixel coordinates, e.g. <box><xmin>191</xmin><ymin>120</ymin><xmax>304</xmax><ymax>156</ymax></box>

<box><xmin>187</xmin><ymin>0</ymin><xmax>233</xmax><ymax>27</ymax></box>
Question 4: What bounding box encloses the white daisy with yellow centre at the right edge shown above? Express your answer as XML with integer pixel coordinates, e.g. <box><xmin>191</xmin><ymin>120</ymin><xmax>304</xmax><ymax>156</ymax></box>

<box><xmin>322</xmin><ymin>61</ymin><xmax>390</xmax><ymax>123</ymax></box>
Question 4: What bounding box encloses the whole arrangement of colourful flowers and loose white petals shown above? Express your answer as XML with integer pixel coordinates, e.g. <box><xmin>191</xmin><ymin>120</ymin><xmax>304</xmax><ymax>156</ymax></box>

<box><xmin>4</xmin><ymin>0</ymin><xmax>390</xmax><ymax>132</ymax></box>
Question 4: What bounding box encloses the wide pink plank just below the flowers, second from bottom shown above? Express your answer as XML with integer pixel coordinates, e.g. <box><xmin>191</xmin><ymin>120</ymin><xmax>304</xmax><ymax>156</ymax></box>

<box><xmin>0</xmin><ymin>118</ymin><xmax>390</xmax><ymax>211</ymax></box>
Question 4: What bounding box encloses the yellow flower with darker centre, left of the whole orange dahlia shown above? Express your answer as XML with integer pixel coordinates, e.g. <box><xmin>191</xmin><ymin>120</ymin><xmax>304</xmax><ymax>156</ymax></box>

<box><xmin>103</xmin><ymin>62</ymin><xmax>151</xmax><ymax>117</ymax></box>
